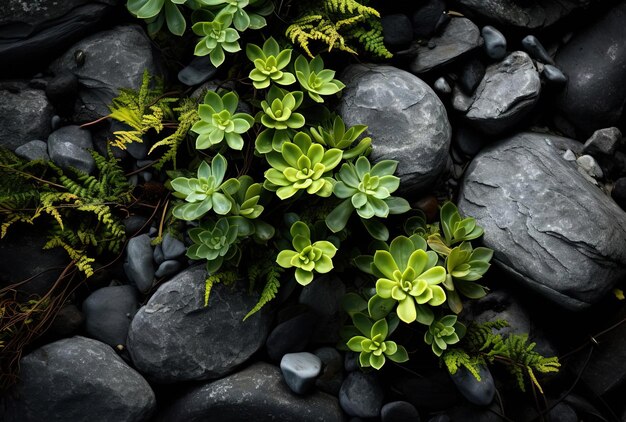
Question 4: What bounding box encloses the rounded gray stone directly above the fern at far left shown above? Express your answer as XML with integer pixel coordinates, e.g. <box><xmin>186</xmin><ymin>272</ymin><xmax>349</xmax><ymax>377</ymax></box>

<box><xmin>48</xmin><ymin>126</ymin><xmax>96</xmax><ymax>174</ymax></box>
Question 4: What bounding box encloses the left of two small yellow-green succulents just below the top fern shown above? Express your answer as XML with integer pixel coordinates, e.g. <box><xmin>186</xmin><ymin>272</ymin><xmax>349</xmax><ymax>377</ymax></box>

<box><xmin>246</xmin><ymin>37</ymin><xmax>296</xmax><ymax>89</ymax></box>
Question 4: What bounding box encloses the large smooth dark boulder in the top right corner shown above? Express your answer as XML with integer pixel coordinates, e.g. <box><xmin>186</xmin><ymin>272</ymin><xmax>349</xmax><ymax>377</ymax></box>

<box><xmin>555</xmin><ymin>0</ymin><xmax>626</xmax><ymax>138</ymax></box>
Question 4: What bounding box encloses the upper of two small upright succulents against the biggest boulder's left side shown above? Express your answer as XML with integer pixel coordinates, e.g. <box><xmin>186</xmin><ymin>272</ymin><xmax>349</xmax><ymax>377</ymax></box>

<box><xmin>428</xmin><ymin>202</ymin><xmax>483</xmax><ymax>255</ymax></box>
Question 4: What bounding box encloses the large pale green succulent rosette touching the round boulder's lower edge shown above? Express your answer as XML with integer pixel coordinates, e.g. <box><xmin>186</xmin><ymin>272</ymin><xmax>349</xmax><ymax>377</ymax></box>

<box><xmin>326</xmin><ymin>156</ymin><xmax>411</xmax><ymax>233</ymax></box>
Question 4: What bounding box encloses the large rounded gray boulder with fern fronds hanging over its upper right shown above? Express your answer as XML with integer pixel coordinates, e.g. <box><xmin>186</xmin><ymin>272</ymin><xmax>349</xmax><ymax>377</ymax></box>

<box><xmin>128</xmin><ymin>266</ymin><xmax>269</xmax><ymax>383</ymax></box>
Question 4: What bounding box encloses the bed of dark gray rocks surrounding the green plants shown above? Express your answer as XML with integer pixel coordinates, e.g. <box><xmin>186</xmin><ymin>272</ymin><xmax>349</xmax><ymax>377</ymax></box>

<box><xmin>0</xmin><ymin>0</ymin><xmax>626</xmax><ymax>422</ymax></box>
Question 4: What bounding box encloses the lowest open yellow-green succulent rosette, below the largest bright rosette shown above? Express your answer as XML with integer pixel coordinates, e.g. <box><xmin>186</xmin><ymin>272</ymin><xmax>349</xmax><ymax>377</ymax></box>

<box><xmin>347</xmin><ymin>313</ymin><xmax>409</xmax><ymax>369</ymax></box>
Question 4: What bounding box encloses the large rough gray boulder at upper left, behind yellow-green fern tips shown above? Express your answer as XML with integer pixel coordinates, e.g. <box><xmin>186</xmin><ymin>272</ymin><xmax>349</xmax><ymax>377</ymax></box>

<box><xmin>50</xmin><ymin>25</ymin><xmax>160</xmax><ymax>122</ymax></box>
